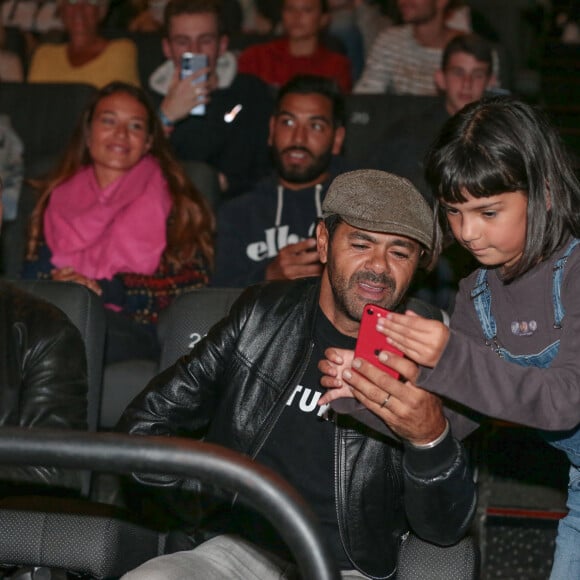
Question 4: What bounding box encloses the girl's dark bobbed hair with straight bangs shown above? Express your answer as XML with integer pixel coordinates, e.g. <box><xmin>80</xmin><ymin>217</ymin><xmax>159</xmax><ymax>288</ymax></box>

<box><xmin>425</xmin><ymin>96</ymin><xmax>580</xmax><ymax>282</ymax></box>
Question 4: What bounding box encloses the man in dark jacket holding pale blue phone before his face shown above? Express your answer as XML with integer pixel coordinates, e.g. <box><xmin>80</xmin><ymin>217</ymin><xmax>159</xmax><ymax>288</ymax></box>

<box><xmin>151</xmin><ymin>0</ymin><xmax>273</xmax><ymax>196</ymax></box>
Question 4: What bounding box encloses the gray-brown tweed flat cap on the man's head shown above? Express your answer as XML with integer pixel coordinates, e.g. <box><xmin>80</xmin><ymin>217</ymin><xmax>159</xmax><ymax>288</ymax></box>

<box><xmin>322</xmin><ymin>169</ymin><xmax>433</xmax><ymax>250</ymax></box>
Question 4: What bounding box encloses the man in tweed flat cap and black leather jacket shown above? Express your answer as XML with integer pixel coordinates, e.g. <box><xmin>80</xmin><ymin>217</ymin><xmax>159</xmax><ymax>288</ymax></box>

<box><xmin>119</xmin><ymin>170</ymin><xmax>476</xmax><ymax>580</ymax></box>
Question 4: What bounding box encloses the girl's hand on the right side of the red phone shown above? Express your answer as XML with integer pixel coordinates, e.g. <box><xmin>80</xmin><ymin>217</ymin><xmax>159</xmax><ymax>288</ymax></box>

<box><xmin>377</xmin><ymin>310</ymin><xmax>449</xmax><ymax>368</ymax></box>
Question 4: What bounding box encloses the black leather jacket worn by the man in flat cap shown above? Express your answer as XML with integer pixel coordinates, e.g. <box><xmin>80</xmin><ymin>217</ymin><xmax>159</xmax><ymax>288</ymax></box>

<box><xmin>119</xmin><ymin>279</ymin><xmax>476</xmax><ymax>578</ymax></box>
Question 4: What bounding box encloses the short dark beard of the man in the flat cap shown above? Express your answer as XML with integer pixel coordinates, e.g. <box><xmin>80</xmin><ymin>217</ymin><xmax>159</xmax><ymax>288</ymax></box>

<box><xmin>327</xmin><ymin>259</ymin><xmax>400</xmax><ymax>322</ymax></box>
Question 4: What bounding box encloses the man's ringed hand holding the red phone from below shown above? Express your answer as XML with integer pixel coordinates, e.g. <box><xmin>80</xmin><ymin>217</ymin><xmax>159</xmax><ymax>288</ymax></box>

<box><xmin>341</xmin><ymin>353</ymin><xmax>446</xmax><ymax>445</ymax></box>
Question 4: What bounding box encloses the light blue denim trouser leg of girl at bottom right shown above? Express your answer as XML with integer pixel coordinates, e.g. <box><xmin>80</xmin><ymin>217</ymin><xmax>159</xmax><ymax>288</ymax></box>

<box><xmin>550</xmin><ymin>465</ymin><xmax>580</xmax><ymax>580</ymax></box>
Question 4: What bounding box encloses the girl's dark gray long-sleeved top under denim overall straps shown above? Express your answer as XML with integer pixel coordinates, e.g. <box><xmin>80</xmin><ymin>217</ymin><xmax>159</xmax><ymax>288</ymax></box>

<box><xmin>417</xmin><ymin>244</ymin><xmax>580</xmax><ymax>430</ymax></box>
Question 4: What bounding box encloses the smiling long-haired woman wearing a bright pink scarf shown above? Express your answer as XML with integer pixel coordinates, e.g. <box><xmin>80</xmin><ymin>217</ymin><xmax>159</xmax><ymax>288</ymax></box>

<box><xmin>24</xmin><ymin>82</ymin><xmax>213</xmax><ymax>362</ymax></box>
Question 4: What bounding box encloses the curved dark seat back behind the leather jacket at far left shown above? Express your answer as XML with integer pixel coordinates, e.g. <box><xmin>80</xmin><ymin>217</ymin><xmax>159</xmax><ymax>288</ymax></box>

<box><xmin>12</xmin><ymin>280</ymin><xmax>105</xmax><ymax>431</ymax></box>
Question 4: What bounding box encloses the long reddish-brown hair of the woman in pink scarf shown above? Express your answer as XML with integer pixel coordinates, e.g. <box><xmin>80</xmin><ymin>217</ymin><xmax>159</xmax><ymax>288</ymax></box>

<box><xmin>27</xmin><ymin>81</ymin><xmax>215</xmax><ymax>267</ymax></box>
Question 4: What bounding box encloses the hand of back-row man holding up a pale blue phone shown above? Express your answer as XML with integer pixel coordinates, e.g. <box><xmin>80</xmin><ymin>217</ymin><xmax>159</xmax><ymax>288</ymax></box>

<box><xmin>160</xmin><ymin>67</ymin><xmax>212</xmax><ymax>123</ymax></box>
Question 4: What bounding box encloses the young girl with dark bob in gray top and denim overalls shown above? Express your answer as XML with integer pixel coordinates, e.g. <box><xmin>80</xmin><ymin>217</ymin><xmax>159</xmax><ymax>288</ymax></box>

<box><xmin>380</xmin><ymin>97</ymin><xmax>580</xmax><ymax>580</ymax></box>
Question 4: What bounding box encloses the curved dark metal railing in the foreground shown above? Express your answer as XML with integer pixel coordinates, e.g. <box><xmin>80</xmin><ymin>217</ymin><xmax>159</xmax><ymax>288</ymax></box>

<box><xmin>0</xmin><ymin>428</ymin><xmax>340</xmax><ymax>580</ymax></box>
